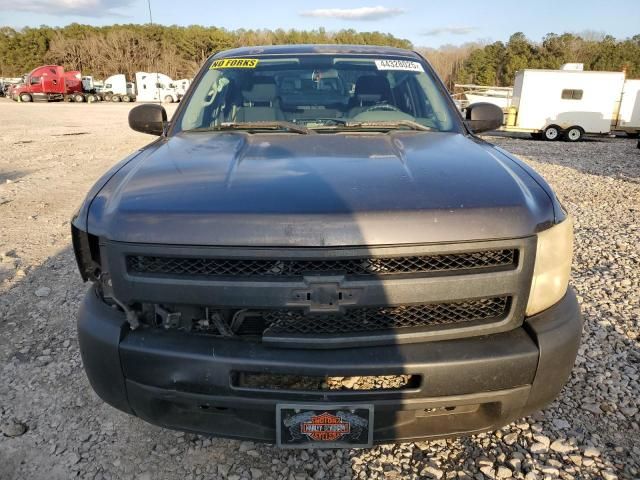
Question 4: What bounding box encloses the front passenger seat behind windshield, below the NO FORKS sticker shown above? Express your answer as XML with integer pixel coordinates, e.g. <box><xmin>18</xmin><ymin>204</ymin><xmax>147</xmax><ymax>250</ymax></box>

<box><xmin>235</xmin><ymin>77</ymin><xmax>284</xmax><ymax>122</ymax></box>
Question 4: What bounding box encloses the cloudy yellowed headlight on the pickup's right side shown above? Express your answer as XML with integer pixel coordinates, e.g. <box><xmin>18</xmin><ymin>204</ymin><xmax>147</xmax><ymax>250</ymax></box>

<box><xmin>526</xmin><ymin>216</ymin><xmax>573</xmax><ymax>316</ymax></box>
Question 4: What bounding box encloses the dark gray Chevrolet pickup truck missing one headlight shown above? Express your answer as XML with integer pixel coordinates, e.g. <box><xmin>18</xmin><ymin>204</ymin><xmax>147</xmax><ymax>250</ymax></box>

<box><xmin>72</xmin><ymin>45</ymin><xmax>582</xmax><ymax>448</ymax></box>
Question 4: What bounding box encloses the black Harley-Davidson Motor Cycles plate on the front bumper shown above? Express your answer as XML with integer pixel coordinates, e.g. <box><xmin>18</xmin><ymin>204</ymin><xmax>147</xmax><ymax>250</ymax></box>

<box><xmin>276</xmin><ymin>404</ymin><xmax>373</xmax><ymax>448</ymax></box>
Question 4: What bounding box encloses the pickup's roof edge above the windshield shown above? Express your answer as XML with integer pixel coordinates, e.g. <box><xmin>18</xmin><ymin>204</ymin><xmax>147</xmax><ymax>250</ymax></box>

<box><xmin>213</xmin><ymin>44</ymin><xmax>420</xmax><ymax>59</ymax></box>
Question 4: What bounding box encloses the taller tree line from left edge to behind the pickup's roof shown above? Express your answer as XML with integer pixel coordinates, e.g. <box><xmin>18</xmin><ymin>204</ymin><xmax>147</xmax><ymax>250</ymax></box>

<box><xmin>0</xmin><ymin>24</ymin><xmax>411</xmax><ymax>78</ymax></box>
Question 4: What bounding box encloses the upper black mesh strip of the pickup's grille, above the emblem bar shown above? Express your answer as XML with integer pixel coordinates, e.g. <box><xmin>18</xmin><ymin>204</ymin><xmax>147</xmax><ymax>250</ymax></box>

<box><xmin>127</xmin><ymin>249</ymin><xmax>518</xmax><ymax>277</ymax></box>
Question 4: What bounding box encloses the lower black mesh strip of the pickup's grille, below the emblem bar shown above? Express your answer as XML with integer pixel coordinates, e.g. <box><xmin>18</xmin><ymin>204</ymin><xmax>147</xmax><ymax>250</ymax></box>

<box><xmin>263</xmin><ymin>297</ymin><xmax>510</xmax><ymax>335</ymax></box>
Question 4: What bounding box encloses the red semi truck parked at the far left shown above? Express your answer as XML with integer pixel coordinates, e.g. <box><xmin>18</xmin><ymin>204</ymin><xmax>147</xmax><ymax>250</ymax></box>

<box><xmin>12</xmin><ymin>65</ymin><xmax>100</xmax><ymax>102</ymax></box>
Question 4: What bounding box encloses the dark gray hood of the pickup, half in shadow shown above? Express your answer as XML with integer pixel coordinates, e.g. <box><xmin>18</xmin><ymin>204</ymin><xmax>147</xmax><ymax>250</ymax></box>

<box><xmin>87</xmin><ymin>131</ymin><xmax>553</xmax><ymax>246</ymax></box>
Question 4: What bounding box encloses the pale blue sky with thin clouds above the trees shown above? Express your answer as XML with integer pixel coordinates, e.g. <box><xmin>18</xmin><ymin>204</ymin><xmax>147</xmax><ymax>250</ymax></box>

<box><xmin>0</xmin><ymin>0</ymin><xmax>640</xmax><ymax>47</ymax></box>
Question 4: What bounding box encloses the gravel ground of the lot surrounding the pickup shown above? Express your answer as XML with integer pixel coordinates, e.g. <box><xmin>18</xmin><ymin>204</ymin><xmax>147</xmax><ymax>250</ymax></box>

<box><xmin>0</xmin><ymin>101</ymin><xmax>640</xmax><ymax>480</ymax></box>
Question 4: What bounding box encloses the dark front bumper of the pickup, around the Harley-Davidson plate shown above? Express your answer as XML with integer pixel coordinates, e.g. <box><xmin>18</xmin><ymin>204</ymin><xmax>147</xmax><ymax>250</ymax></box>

<box><xmin>78</xmin><ymin>289</ymin><xmax>582</xmax><ymax>443</ymax></box>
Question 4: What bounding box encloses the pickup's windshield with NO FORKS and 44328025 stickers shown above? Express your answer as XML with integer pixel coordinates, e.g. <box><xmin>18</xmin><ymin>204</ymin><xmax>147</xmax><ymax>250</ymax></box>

<box><xmin>176</xmin><ymin>55</ymin><xmax>456</xmax><ymax>131</ymax></box>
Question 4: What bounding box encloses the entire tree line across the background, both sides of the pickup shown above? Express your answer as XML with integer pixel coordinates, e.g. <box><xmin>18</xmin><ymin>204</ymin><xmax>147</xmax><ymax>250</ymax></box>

<box><xmin>0</xmin><ymin>24</ymin><xmax>640</xmax><ymax>89</ymax></box>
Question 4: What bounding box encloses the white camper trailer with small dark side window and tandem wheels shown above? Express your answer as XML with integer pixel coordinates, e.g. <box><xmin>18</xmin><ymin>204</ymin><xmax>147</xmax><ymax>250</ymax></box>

<box><xmin>502</xmin><ymin>64</ymin><xmax>625</xmax><ymax>142</ymax></box>
